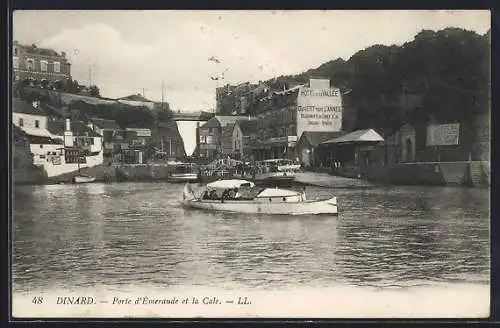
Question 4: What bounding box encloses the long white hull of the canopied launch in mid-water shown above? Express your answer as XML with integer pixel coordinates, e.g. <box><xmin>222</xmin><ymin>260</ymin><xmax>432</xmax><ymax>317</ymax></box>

<box><xmin>183</xmin><ymin>197</ymin><xmax>338</xmax><ymax>215</ymax></box>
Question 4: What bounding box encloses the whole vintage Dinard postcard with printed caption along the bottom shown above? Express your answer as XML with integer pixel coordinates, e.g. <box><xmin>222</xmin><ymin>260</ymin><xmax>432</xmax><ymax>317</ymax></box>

<box><xmin>10</xmin><ymin>10</ymin><xmax>491</xmax><ymax>319</ymax></box>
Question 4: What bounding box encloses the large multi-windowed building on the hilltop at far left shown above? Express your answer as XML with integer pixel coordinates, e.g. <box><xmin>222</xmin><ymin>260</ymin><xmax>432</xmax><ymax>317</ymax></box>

<box><xmin>12</xmin><ymin>41</ymin><xmax>72</xmax><ymax>89</ymax></box>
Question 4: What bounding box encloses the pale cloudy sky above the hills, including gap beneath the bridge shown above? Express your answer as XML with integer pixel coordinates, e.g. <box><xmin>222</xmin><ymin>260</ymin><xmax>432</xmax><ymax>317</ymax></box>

<box><xmin>12</xmin><ymin>10</ymin><xmax>490</xmax><ymax>153</ymax></box>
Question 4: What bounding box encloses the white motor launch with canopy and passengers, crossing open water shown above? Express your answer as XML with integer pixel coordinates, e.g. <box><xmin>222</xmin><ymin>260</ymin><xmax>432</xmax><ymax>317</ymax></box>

<box><xmin>182</xmin><ymin>179</ymin><xmax>337</xmax><ymax>215</ymax></box>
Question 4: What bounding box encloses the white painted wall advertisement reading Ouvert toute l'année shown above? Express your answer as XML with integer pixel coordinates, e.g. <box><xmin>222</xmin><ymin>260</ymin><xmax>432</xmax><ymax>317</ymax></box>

<box><xmin>297</xmin><ymin>87</ymin><xmax>342</xmax><ymax>138</ymax></box>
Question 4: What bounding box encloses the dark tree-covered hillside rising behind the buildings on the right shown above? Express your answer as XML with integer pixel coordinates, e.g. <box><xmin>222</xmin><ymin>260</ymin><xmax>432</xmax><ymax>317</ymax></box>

<box><xmin>258</xmin><ymin>28</ymin><xmax>491</xmax><ymax>130</ymax></box>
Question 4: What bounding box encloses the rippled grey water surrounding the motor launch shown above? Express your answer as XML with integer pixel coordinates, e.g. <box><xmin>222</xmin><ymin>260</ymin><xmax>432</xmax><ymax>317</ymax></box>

<box><xmin>12</xmin><ymin>183</ymin><xmax>489</xmax><ymax>292</ymax></box>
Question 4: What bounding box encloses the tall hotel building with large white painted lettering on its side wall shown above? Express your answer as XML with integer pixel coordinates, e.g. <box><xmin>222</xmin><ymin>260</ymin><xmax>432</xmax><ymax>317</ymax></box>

<box><xmin>255</xmin><ymin>78</ymin><xmax>342</xmax><ymax>163</ymax></box>
